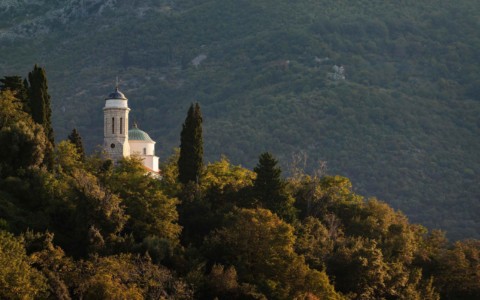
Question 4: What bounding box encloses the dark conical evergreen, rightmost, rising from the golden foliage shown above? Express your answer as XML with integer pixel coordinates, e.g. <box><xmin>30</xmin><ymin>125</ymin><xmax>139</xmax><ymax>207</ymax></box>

<box><xmin>252</xmin><ymin>152</ymin><xmax>296</xmax><ymax>222</ymax></box>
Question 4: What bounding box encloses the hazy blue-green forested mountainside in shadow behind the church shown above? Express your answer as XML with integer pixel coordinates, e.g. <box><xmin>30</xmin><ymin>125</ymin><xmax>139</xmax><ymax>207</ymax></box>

<box><xmin>0</xmin><ymin>0</ymin><xmax>480</xmax><ymax>238</ymax></box>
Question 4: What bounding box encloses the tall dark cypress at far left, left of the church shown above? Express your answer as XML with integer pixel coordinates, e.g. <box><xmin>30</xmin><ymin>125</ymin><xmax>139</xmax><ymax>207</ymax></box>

<box><xmin>28</xmin><ymin>65</ymin><xmax>55</xmax><ymax>168</ymax></box>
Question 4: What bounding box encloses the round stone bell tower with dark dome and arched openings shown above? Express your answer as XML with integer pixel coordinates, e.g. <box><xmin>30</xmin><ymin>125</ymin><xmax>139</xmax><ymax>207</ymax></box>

<box><xmin>103</xmin><ymin>83</ymin><xmax>130</xmax><ymax>161</ymax></box>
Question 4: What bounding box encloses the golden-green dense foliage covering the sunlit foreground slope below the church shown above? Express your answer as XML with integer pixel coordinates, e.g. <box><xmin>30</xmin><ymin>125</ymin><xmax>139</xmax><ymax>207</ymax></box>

<box><xmin>0</xmin><ymin>76</ymin><xmax>480</xmax><ymax>300</ymax></box>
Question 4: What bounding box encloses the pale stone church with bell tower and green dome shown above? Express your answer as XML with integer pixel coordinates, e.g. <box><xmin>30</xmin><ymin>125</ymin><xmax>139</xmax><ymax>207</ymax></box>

<box><xmin>103</xmin><ymin>85</ymin><xmax>159</xmax><ymax>174</ymax></box>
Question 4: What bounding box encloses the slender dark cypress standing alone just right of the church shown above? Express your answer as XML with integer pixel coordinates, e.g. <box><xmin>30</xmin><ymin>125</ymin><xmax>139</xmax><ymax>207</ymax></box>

<box><xmin>178</xmin><ymin>103</ymin><xmax>203</xmax><ymax>184</ymax></box>
